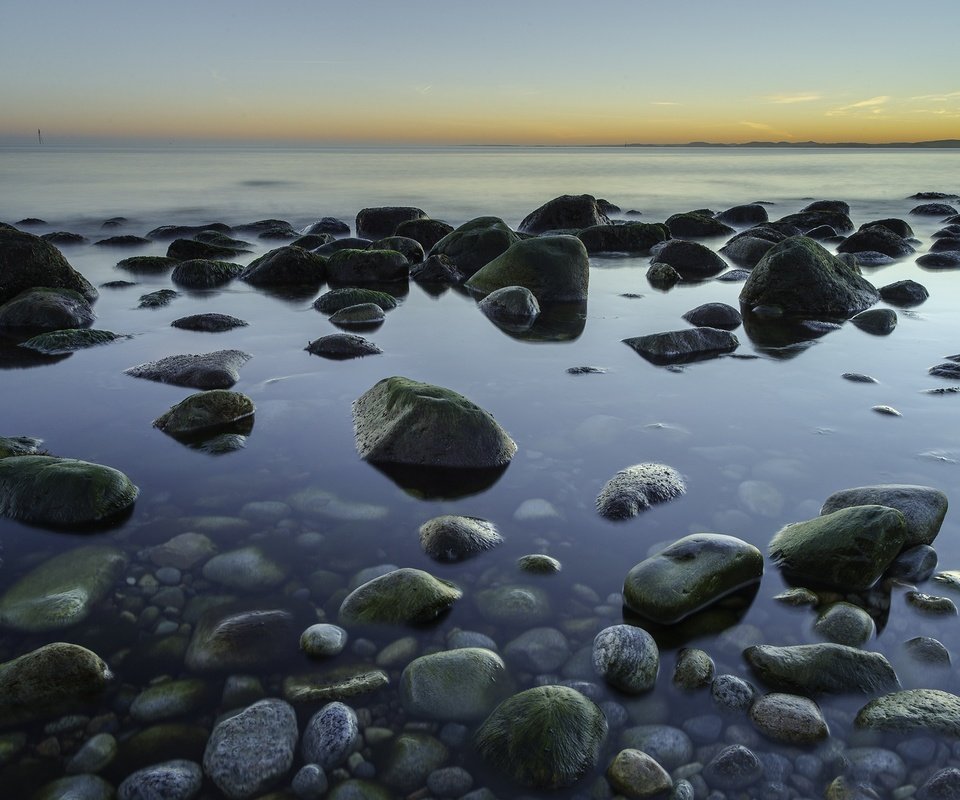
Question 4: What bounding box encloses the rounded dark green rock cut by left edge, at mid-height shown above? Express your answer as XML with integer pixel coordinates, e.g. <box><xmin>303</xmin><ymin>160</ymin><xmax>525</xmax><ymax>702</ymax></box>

<box><xmin>0</xmin><ymin>455</ymin><xmax>140</xmax><ymax>527</ymax></box>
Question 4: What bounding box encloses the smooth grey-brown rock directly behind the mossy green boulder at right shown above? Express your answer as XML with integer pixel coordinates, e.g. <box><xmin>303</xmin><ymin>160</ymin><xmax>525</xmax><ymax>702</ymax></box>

<box><xmin>820</xmin><ymin>484</ymin><xmax>947</xmax><ymax>547</ymax></box>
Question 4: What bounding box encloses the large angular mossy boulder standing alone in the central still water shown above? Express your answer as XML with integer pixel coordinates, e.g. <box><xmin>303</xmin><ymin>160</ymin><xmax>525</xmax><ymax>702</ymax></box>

<box><xmin>353</xmin><ymin>377</ymin><xmax>517</xmax><ymax>468</ymax></box>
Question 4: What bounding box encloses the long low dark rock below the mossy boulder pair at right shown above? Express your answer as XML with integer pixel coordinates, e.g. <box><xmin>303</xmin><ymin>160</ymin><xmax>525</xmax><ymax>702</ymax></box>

<box><xmin>743</xmin><ymin>643</ymin><xmax>900</xmax><ymax>694</ymax></box>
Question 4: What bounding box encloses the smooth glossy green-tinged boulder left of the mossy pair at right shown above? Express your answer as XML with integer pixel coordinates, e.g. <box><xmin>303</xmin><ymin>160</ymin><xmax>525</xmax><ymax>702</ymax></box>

<box><xmin>623</xmin><ymin>533</ymin><xmax>763</xmax><ymax>624</ymax></box>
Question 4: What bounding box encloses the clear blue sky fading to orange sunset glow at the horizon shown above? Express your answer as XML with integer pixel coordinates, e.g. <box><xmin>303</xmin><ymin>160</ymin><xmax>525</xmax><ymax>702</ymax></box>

<box><xmin>0</xmin><ymin>0</ymin><xmax>960</xmax><ymax>145</ymax></box>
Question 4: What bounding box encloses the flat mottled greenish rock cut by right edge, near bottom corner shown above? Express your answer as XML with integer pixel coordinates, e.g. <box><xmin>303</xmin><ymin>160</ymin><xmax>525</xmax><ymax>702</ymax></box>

<box><xmin>854</xmin><ymin>689</ymin><xmax>960</xmax><ymax>738</ymax></box>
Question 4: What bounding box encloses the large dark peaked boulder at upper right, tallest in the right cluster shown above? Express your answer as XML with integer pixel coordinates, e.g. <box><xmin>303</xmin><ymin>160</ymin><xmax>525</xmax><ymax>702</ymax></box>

<box><xmin>740</xmin><ymin>236</ymin><xmax>880</xmax><ymax>319</ymax></box>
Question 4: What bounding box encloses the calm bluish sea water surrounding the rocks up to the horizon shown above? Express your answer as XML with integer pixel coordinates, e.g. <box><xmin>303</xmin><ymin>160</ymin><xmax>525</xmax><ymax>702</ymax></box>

<box><xmin>0</xmin><ymin>146</ymin><xmax>960</xmax><ymax>797</ymax></box>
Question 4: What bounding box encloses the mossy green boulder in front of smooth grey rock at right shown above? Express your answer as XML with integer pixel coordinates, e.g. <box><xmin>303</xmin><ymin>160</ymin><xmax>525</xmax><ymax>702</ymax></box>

<box><xmin>770</xmin><ymin>505</ymin><xmax>907</xmax><ymax>591</ymax></box>
